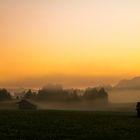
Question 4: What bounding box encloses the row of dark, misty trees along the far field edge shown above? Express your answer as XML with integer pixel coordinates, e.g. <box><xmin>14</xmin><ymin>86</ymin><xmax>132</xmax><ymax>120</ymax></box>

<box><xmin>0</xmin><ymin>84</ymin><xmax>108</xmax><ymax>103</ymax></box>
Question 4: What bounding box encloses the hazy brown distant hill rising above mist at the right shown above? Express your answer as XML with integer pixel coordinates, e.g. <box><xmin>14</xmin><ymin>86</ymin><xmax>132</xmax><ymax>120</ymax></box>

<box><xmin>114</xmin><ymin>77</ymin><xmax>140</xmax><ymax>89</ymax></box>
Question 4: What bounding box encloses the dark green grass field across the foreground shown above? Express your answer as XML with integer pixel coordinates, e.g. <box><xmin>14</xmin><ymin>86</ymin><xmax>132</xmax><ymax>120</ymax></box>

<box><xmin>0</xmin><ymin>111</ymin><xmax>140</xmax><ymax>140</ymax></box>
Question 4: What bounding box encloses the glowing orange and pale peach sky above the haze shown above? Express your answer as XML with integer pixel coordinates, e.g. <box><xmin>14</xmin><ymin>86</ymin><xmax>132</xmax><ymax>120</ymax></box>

<box><xmin>0</xmin><ymin>0</ymin><xmax>140</xmax><ymax>87</ymax></box>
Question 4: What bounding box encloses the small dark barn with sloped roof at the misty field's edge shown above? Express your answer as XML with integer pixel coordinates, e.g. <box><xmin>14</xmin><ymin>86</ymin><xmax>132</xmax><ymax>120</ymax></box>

<box><xmin>18</xmin><ymin>99</ymin><xmax>37</xmax><ymax>110</ymax></box>
